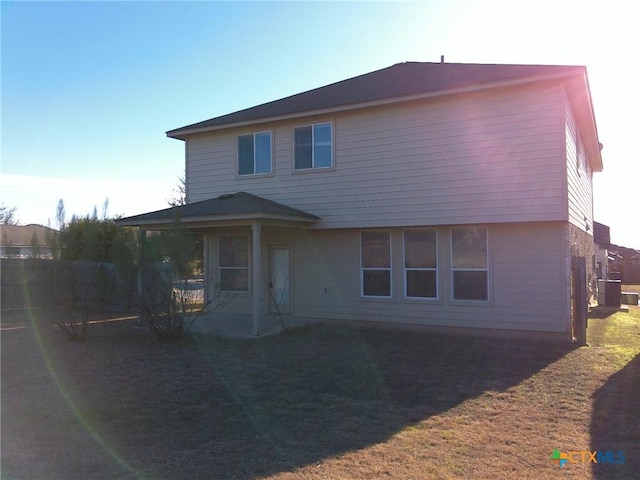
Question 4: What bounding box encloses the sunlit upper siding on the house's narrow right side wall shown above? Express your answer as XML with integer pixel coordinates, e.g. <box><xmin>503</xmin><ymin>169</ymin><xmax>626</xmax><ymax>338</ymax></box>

<box><xmin>565</xmin><ymin>94</ymin><xmax>593</xmax><ymax>230</ymax></box>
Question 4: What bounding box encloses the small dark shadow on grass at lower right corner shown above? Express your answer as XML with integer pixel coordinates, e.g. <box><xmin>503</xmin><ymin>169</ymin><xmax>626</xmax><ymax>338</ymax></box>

<box><xmin>591</xmin><ymin>354</ymin><xmax>640</xmax><ymax>480</ymax></box>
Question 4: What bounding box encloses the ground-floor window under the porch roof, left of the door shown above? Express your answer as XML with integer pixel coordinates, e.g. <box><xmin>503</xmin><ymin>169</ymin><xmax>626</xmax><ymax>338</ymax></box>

<box><xmin>218</xmin><ymin>235</ymin><xmax>249</xmax><ymax>292</ymax></box>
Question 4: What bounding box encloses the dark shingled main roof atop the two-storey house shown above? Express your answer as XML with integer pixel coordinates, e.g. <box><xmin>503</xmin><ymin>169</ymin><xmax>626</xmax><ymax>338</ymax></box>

<box><xmin>167</xmin><ymin>62</ymin><xmax>586</xmax><ymax>139</ymax></box>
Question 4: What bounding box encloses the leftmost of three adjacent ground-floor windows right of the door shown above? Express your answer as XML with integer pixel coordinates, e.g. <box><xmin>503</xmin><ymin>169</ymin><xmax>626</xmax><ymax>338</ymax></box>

<box><xmin>360</xmin><ymin>231</ymin><xmax>391</xmax><ymax>297</ymax></box>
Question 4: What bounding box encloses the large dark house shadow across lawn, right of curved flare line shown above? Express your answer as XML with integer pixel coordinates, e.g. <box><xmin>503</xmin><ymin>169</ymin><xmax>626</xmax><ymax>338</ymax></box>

<box><xmin>10</xmin><ymin>323</ymin><xmax>568</xmax><ymax>479</ymax></box>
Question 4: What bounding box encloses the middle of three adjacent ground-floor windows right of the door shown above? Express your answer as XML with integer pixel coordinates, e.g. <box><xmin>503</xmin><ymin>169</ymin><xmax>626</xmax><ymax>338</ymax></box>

<box><xmin>404</xmin><ymin>228</ymin><xmax>438</xmax><ymax>298</ymax></box>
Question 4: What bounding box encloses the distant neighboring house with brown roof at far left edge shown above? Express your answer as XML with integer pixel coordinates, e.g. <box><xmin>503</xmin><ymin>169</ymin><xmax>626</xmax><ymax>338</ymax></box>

<box><xmin>0</xmin><ymin>224</ymin><xmax>58</xmax><ymax>259</ymax></box>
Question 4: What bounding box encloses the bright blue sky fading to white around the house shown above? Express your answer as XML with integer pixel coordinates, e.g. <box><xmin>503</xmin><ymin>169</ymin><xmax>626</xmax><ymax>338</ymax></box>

<box><xmin>0</xmin><ymin>0</ymin><xmax>640</xmax><ymax>248</ymax></box>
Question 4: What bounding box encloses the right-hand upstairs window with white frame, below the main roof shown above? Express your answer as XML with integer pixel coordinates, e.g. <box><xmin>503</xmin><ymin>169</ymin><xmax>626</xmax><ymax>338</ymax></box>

<box><xmin>293</xmin><ymin>123</ymin><xmax>333</xmax><ymax>170</ymax></box>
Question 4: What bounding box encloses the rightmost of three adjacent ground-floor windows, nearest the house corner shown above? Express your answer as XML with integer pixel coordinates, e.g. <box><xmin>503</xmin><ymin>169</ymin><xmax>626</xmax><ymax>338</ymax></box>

<box><xmin>451</xmin><ymin>227</ymin><xmax>489</xmax><ymax>301</ymax></box>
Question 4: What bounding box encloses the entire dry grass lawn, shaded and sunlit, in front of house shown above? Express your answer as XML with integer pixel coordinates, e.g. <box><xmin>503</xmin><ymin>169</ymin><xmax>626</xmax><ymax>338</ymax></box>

<box><xmin>1</xmin><ymin>307</ymin><xmax>640</xmax><ymax>480</ymax></box>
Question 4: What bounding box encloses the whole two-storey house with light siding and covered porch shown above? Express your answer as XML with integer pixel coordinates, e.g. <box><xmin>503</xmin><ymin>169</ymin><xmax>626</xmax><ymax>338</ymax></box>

<box><xmin>119</xmin><ymin>62</ymin><xmax>602</xmax><ymax>339</ymax></box>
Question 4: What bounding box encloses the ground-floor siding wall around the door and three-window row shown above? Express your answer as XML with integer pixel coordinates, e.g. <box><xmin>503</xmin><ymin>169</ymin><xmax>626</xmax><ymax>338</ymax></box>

<box><xmin>202</xmin><ymin>222</ymin><xmax>569</xmax><ymax>333</ymax></box>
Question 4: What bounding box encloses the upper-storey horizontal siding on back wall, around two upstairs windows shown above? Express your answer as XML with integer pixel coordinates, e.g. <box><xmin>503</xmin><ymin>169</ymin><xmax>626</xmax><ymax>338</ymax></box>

<box><xmin>187</xmin><ymin>86</ymin><xmax>568</xmax><ymax>229</ymax></box>
